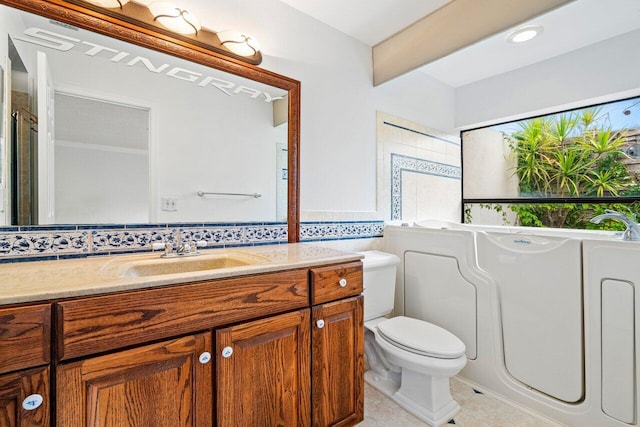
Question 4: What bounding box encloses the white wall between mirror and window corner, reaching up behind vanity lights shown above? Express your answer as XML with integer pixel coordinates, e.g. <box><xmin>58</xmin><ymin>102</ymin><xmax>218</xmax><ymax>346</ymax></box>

<box><xmin>180</xmin><ymin>0</ymin><xmax>454</xmax><ymax>220</ymax></box>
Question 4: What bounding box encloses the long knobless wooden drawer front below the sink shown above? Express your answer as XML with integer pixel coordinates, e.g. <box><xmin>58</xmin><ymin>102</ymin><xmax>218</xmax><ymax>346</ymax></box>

<box><xmin>58</xmin><ymin>269</ymin><xmax>309</xmax><ymax>360</ymax></box>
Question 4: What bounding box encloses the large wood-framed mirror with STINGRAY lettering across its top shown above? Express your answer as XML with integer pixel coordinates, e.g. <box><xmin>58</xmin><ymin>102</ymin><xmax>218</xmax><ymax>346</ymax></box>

<box><xmin>0</xmin><ymin>0</ymin><xmax>300</xmax><ymax>241</ymax></box>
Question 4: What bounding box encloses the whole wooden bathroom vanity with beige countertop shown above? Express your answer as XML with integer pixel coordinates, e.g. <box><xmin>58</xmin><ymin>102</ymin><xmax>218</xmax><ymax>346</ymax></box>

<box><xmin>0</xmin><ymin>244</ymin><xmax>364</xmax><ymax>427</ymax></box>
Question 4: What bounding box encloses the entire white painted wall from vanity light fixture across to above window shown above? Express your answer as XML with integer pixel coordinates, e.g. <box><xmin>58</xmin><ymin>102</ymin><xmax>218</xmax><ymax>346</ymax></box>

<box><xmin>12</xmin><ymin>0</ymin><xmax>640</xmax><ymax>227</ymax></box>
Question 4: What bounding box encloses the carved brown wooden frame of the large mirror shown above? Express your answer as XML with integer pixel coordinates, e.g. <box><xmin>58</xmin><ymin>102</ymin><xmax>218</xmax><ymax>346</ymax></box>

<box><xmin>0</xmin><ymin>0</ymin><xmax>300</xmax><ymax>243</ymax></box>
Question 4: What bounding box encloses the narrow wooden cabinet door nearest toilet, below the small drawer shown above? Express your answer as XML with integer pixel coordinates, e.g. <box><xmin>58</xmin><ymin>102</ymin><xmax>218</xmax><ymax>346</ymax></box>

<box><xmin>311</xmin><ymin>296</ymin><xmax>364</xmax><ymax>426</ymax></box>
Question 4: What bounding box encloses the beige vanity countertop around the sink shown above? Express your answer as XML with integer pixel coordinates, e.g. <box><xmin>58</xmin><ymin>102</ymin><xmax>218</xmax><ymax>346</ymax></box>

<box><xmin>0</xmin><ymin>243</ymin><xmax>363</xmax><ymax>305</ymax></box>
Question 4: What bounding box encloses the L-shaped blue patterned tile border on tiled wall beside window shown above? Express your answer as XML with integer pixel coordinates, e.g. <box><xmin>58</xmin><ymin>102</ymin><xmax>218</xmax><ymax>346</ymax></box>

<box><xmin>391</xmin><ymin>153</ymin><xmax>462</xmax><ymax>220</ymax></box>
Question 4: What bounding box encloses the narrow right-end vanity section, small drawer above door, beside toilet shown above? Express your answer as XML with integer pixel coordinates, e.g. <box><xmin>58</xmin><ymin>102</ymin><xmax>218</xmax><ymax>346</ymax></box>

<box><xmin>310</xmin><ymin>261</ymin><xmax>364</xmax><ymax>426</ymax></box>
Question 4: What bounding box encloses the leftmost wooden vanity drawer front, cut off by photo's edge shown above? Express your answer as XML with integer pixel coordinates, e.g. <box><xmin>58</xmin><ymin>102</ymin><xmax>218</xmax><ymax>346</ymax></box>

<box><xmin>0</xmin><ymin>304</ymin><xmax>51</xmax><ymax>373</ymax></box>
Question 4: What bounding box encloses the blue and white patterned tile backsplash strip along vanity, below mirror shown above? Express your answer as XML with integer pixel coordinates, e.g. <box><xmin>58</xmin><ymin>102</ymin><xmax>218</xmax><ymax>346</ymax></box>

<box><xmin>0</xmin><ymin>221</ymin><xmax>384</xmax><ymax>262</ymax></box>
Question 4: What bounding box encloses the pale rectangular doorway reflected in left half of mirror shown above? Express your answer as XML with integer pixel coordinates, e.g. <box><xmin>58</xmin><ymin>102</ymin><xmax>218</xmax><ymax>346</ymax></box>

<box><xmin>53</xmin><ymin>91</ymin><xmax>150</xmax><ymax>224</ymax></box>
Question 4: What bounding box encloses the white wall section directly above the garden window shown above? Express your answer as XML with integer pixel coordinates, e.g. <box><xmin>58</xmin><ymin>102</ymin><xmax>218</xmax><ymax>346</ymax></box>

<box><xmin>455</xmin><ymin>30</ymin><xmax>640</xmax><ymax>128</ymax></box>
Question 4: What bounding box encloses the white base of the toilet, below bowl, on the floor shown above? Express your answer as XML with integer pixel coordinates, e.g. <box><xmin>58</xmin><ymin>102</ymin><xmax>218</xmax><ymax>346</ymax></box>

<box><xmin>364</xmin><ymin>368</ymin><xmax>460</xmax><ymax>427</ymax></box>
